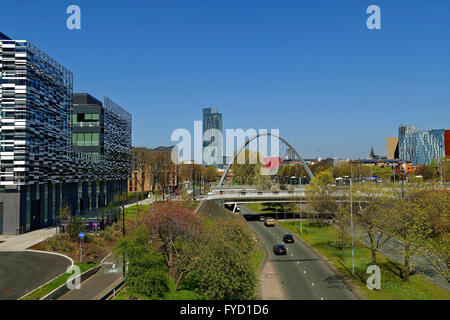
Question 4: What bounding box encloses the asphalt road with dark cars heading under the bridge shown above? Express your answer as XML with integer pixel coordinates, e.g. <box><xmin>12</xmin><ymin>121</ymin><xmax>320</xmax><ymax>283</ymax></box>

<box><xmin>241</xmin><ymin>206</ymin><xmax>356</xmax><ymax>300</ymax></box>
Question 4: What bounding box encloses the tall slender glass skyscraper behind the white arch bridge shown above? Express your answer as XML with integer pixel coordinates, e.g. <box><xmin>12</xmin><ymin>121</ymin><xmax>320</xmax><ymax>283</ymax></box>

<box><xmin>203</xmin><ymin>107</ymin><xmax>223</xmax><ymax>167</ymax></box>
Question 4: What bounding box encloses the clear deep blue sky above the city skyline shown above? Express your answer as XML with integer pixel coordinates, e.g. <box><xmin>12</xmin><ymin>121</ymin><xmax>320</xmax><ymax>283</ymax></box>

<box><xmin>0</xmin><ymin>0</ymin><xmax>450</xmax><ymax>158</ymax></box>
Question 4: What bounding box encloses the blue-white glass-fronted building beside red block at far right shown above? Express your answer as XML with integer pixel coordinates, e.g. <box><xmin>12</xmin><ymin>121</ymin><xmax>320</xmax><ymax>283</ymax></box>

<box><xmin>398</xmin><ymin>126</ymin><xmax>450</xmax><ymax>166</ymax></box>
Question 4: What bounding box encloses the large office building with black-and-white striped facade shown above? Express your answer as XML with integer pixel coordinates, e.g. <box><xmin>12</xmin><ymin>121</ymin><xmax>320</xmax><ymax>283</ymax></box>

<box><xmin>0</xmin><ymin>33</ymin><xmax>131</xmax><ymax>234</ymax></box>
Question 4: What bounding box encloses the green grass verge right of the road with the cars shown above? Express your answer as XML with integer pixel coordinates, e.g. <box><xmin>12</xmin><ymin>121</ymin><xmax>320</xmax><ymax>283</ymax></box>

<box><xmin>279</xmin><ymin>221</ymin><xmax>450</xmax><ymax>300</ymax></box>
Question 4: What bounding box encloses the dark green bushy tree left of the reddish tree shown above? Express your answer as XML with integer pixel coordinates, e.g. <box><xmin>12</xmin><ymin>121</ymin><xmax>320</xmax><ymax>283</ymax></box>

<box><xmin>114</xmin><ymin>228</ymin><xmax>169</xmax><ymax>297</ymax></box>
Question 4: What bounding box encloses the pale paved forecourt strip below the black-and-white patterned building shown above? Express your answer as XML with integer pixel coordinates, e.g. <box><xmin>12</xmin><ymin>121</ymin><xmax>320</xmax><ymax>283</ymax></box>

<box><xmin>0</xmin><ymin>228</ymin><xmax>56</xmax><ymax>251</ymax></box>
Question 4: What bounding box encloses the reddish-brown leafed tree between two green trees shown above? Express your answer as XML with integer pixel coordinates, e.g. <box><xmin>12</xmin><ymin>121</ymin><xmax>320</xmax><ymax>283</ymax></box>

<box><xmin>144</xmin><ymin>201</ymin><xmax>201</xmax><ymax>288</ymax></box>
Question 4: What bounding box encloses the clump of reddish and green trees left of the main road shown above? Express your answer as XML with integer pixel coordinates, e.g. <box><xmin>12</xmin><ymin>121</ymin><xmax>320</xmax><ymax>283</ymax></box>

<box><xmin>115</xmin><ymin>202</ymin><xmax>256</xmax><ymax>300</ymax></box>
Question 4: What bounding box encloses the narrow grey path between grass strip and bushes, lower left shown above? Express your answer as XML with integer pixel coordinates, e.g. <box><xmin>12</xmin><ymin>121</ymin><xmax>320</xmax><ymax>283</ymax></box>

<box><xmin>58</xmin><ymin>255</ymin><xmax>122</xmax><ymax>300</ymax></box>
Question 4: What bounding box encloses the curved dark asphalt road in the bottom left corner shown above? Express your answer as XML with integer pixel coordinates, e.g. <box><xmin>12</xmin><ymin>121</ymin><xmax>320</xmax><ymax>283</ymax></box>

<box><xmin>0</xmin><ymin>251</ymin><xmax>71</xmax><ymax>300</ymax></box>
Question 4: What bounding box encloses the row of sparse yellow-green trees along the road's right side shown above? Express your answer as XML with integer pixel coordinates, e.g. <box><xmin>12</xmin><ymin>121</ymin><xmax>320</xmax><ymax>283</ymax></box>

<box><xmin>307</xmin><ymin>170</ymin><xmax>450</xmax><ymax>281</ymax></box>
